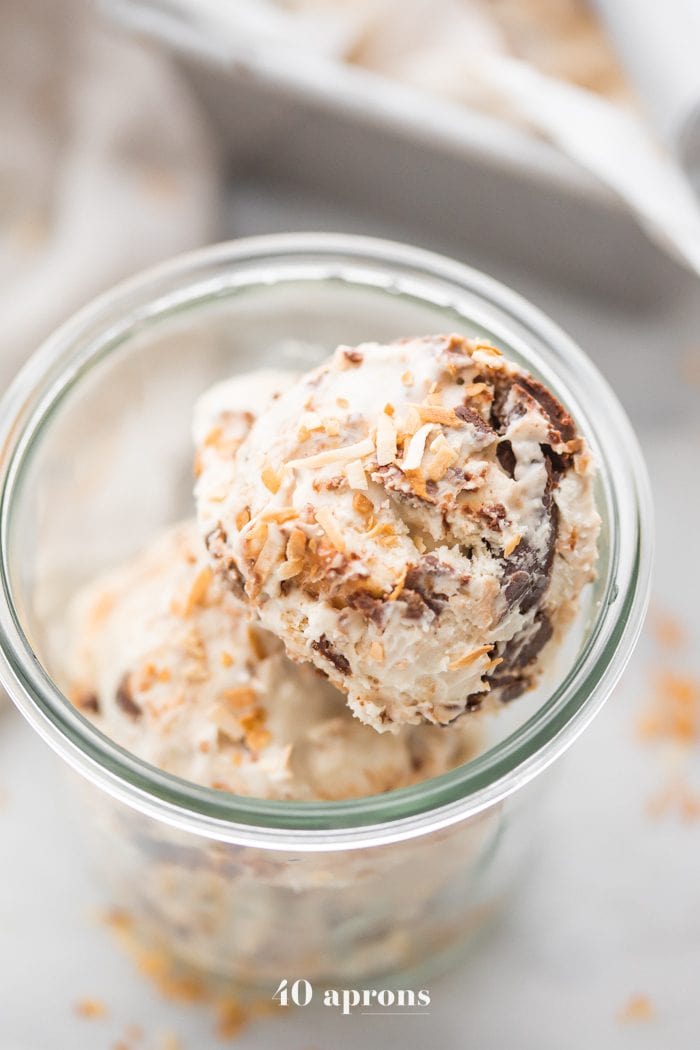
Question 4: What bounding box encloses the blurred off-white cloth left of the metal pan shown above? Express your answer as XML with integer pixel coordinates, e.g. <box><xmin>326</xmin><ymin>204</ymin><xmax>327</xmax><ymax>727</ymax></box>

<box><xmin>0</xmin><ymin>0</ymin><xmax>218</xmax><ymax>390</ymax></box>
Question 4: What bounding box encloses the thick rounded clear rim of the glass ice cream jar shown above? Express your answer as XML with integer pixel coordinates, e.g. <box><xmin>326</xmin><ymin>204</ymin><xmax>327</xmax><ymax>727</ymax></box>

<box><xmin>0</xmin><ymin>233</ymin><xmax>652</xmax><ymax>851</ymax></box>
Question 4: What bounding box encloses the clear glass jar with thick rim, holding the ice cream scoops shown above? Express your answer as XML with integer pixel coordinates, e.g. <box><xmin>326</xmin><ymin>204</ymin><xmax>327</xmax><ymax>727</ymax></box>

<box><xmin>0</xmin><ymin>234</ymin><xmax>652</xmax><ymax>990</ymax></box>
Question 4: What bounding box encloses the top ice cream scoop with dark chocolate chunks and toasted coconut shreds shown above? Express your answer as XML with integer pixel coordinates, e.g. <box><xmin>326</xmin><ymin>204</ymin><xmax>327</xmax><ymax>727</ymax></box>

<box><xmin>197</xmin><ymin>336</ymin><xmax>599</xmax><ymax>731</ymax></box>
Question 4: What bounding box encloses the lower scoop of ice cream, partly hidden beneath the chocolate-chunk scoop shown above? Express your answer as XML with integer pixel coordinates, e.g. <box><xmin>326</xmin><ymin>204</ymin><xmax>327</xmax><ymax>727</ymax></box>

<box><xmin>67</xmin><ymin>523</ymin><xmax>478</xmax><ymax>799</ymax></box>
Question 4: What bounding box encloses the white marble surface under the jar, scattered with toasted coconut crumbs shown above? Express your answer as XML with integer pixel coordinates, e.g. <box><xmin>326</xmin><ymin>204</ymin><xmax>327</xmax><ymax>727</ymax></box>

<box><xmin>0</xmin><ymin>186</ymin><xmax>700</xmax><ymax>1050</ymax></box>
